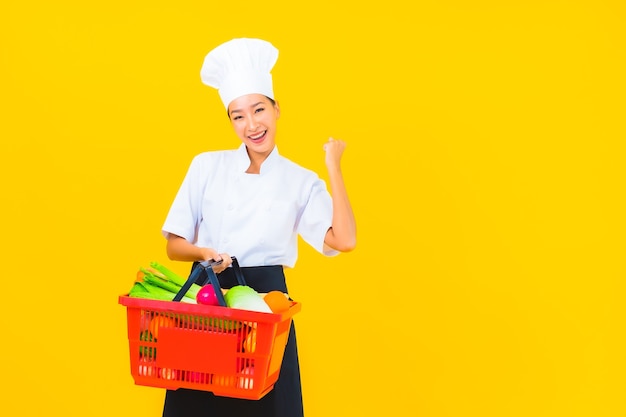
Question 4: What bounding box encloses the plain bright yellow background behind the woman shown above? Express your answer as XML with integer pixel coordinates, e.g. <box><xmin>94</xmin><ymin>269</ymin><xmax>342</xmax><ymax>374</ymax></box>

<box><xmin>0</xmin><ymin>0</ymin><xmax>626</xmax><ymax>417</ymax></box>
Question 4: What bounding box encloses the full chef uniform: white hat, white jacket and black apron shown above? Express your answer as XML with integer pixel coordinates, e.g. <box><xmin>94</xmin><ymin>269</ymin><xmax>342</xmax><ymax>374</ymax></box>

<box><xmin>162</xmin><ymin>38</ymin><xmax>338</xmax><ymax>417</ymax></box>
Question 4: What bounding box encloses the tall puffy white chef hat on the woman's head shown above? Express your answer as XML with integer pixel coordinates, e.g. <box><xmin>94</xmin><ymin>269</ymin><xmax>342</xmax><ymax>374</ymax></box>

<box><xmin>200</xmin><ymin>38</ymin><xmax>278</xmax><ymax>109</ymax></box>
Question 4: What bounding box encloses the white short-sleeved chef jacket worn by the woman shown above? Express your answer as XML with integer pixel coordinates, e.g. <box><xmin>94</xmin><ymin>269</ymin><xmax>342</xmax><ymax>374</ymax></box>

<box><xmin>162</xmin><ymin>143</ymin><xmax>338</xmax><ymax>267</ymax></box>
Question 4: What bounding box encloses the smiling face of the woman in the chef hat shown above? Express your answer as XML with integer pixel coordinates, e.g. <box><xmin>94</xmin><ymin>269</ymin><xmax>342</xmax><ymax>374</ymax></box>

<box><xmin>228</xmin><ymin>94</ymin><xmax>280</xmax><ymax>156</ymax></box>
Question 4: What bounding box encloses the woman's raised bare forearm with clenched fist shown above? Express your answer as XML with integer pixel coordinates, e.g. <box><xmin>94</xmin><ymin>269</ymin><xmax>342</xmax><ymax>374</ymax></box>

<box><xmin>324</xmin><ymin>138</ymin><xmax>356</xmax><ymax>252</ymax></box>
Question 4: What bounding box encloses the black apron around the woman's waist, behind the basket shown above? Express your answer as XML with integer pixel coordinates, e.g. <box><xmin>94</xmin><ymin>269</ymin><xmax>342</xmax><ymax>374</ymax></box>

<box><xmin>163</xmin><ymin>264</ymin><xmax>304</xmax><ymax>417</ymax></box>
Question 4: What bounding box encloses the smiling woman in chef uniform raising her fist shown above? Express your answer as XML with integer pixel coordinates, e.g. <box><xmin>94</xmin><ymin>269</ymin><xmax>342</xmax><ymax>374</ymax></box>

<box><xmin>162</xmin><ymin>38</ymin><xmax>356</xmax><ymax>417</ymax></box>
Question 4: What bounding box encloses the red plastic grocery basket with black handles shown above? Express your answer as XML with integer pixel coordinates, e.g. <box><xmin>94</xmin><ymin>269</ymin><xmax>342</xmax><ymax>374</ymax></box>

<box><xmin>119</xmin><ymin>257</ymin><xmax>301</xmax><ymax>400</ymax></box>
